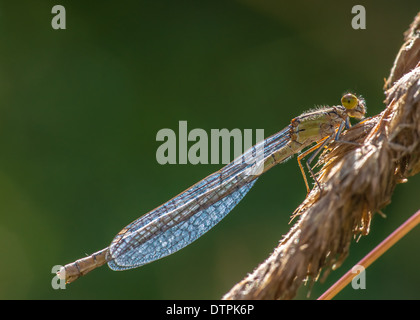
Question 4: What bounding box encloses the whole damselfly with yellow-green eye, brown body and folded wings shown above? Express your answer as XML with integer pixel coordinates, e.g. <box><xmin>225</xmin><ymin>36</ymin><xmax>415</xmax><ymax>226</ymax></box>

<box><xmin>58</xmin><ymin>94</ymin><xmax>366</xmax><ymax>283</ymax></box>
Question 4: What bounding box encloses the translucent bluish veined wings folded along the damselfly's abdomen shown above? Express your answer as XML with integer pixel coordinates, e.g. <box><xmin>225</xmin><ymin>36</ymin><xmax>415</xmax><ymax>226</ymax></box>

<box><xmin>108</xmin><ymin>126</ymin><xmax>291</xmax><ymax>270</ymax></box>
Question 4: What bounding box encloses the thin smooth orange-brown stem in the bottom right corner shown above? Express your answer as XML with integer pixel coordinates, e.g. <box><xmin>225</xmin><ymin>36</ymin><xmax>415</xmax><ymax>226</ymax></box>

<box><xmin>318</xmin><ymin>210</ymin><xmax>420</xmax><ymax>300</ymax></box>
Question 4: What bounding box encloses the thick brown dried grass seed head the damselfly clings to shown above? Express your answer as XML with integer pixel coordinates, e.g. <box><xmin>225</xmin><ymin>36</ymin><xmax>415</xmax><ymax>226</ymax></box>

<box><xmin>223</xmin><ymin>11</ymin><xmax>420</xmax><ymax>299</ymax></box>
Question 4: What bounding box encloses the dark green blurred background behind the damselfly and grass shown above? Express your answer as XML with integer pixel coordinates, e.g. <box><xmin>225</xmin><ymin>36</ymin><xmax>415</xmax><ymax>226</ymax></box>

<box><xmin>0</xmin><ymin>0</ymin><xmax>420</xmax><ymax>299</ymax></box>
